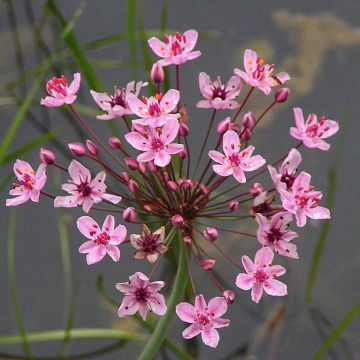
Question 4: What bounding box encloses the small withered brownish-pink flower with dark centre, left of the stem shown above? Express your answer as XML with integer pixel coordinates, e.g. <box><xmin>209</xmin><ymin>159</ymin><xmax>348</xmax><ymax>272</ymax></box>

<box><xmin>130</xmin><ymin>224</ymin><xmax>168</xmax><ymax>263</ymax></box>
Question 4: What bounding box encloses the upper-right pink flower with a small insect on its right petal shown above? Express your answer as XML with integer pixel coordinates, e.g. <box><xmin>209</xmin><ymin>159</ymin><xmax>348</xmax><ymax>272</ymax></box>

<box><xmin>234</xmin><ymin>49</ymin><xmax>290</xmax><ymax>95</ymax></box>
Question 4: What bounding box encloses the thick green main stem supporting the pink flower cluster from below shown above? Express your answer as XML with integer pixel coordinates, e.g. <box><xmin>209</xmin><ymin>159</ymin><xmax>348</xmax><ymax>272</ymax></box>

<box><xmin>139</xmin><ymin>233</ymin><xmax>188</xmax><ymax>360</ymax></box>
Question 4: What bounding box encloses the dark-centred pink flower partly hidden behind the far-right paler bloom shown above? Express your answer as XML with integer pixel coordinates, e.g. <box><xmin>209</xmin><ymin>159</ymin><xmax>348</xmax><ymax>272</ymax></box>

<box><xmin>268</xmin><ymin>149</ymin><xmax>301</xmax><ymax>190</ymax></box>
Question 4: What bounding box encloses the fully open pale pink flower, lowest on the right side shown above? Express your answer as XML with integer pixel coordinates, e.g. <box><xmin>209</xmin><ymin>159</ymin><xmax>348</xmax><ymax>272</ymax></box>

<box><xmin>236</xmin><ymin>247</ymin><xmax>287</xmax><ymax>303</ymax></box>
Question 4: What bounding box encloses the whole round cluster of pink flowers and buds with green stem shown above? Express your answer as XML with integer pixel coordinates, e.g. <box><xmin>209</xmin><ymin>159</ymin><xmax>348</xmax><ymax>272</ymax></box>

<box><xmin>6</xmin><ymin>30</ymin><xmax>338</xmax><ymax>359</ymax></box>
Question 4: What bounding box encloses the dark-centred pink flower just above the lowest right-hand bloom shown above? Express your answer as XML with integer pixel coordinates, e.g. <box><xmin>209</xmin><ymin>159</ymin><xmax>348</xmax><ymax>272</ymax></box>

<box><xmin>255</xmin><ymin>211</ymin><xmax>299</xmax><ymax>259</ymax></box>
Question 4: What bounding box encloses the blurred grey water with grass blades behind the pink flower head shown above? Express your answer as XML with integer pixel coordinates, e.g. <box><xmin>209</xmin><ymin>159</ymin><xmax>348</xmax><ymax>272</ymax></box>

<box><xmin>0</xmin><ymin>0</ymin><xmax>360</xmax><ymax>359</ymax></box>
